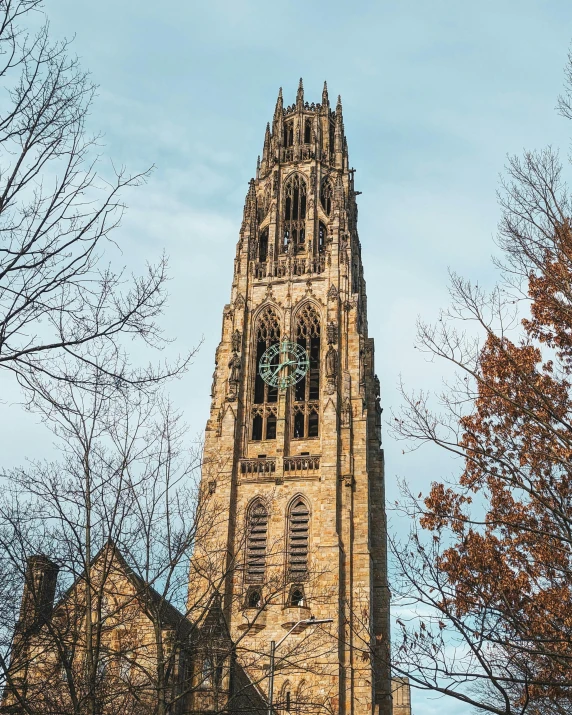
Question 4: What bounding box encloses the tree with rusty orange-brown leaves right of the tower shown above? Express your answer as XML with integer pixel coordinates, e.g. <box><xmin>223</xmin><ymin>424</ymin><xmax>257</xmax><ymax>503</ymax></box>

<box><xmin>392</xmin><ymin>53</ymin><xmax>572</xmax><ymax>715</ymax></box>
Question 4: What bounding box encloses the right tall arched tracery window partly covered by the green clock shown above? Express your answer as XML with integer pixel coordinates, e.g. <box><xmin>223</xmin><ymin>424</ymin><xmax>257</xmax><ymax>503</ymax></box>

<box><xmin>292</xmin><ymin>303</ymin><xmax>320</xmax><ymax>439</ymax></box>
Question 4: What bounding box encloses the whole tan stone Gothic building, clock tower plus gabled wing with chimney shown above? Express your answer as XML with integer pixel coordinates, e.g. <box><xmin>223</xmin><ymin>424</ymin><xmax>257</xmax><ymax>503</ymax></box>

<box><xmin>0</xmin><ymin>80</ymin><xmax>411</xmax><ymax>715</ymax></box>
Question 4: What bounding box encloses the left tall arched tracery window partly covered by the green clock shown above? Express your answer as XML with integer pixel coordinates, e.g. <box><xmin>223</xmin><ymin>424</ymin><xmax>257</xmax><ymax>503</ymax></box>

<box><xmin>251</xmin><ymin>306</ymin><xmax>280</xmax><ymax>441</ymax></box>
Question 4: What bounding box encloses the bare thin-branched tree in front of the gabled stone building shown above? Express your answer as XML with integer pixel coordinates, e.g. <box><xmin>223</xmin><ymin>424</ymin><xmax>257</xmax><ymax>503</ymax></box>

<box><xmin>0</xmin><ymin>368</ymin><xmax>337</xmax><ymax>715</ymax></box>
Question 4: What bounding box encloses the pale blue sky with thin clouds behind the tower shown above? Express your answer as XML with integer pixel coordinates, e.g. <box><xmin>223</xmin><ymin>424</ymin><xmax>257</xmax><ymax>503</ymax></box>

<box><xmin>0</xmin><ymin>0</ymin><xmax>572</xmax><ymax>715</ymax></box>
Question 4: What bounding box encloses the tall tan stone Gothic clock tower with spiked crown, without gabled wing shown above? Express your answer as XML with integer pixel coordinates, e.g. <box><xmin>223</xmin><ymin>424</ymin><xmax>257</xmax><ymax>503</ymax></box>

<box><xmin>189</xmin><ymin>80</ymin><xmax>391</xmax><ymax>715</ymax></box>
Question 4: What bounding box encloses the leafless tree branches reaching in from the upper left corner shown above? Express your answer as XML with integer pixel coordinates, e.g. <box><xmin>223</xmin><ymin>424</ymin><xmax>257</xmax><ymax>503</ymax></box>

<box><xmin>0</xmin><ymin>0</ymin><xmax>185</xmax><ymax>406</ymax></box>
